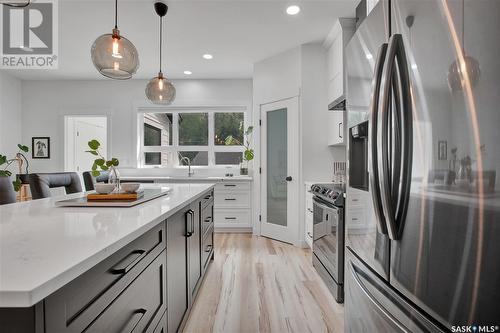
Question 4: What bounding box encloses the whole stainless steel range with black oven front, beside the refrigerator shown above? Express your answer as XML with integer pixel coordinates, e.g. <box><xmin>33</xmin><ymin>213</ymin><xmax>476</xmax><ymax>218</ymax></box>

<box><xmin>311</xmin><ymin>184</ymin><xmax>344</xmax><ymax>303</ymax></box>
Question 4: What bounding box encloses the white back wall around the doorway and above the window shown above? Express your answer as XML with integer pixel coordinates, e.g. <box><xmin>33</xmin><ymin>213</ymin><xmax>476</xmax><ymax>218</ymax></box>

<box><xmin>22</xmin><ymin>80</ymin><xmax>252</xmax><ymax>172</ymax></box>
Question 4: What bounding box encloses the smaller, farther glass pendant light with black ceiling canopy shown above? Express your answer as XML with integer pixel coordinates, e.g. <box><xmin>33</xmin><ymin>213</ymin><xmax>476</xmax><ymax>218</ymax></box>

<box><xmin>146</xmin><ymin>2</ymin><xmax>175</xmax><ymax>105</ymax></box>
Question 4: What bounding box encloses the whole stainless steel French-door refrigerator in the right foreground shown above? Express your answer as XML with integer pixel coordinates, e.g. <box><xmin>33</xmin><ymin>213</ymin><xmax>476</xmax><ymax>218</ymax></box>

<box><xmin>345</xmin><ymin>0</ymin><xmax>500</xmax><ymax>333</ymax></box>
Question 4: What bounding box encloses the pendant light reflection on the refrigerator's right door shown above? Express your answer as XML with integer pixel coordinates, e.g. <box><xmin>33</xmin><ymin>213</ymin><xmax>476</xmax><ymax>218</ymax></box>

<box><xmin>448</xmin><ymin>0</ymin><xmax>481</xmax><ymax>91</ymax></box>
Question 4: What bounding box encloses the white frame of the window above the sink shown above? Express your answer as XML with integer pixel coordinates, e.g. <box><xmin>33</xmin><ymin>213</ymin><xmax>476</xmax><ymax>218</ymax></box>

<box><xmin>136</xmin><ymin>106</ymin><xmax>249</xmax><ymax>169</ymax></box>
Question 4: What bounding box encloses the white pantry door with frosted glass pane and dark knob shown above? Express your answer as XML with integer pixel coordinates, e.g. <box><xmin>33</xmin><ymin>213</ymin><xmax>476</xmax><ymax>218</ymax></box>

<box><xmin>261</xmin><ymin>97</ymin><xmax>300</xmax><ymax>243</ymax></box>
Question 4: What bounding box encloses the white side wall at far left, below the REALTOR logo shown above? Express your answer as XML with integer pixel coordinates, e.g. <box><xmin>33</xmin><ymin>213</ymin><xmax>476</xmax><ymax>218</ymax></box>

<box><xmin>0</xmin><ymin>71</ymin><xmax>22</xmax><ymax>162</ymax></box>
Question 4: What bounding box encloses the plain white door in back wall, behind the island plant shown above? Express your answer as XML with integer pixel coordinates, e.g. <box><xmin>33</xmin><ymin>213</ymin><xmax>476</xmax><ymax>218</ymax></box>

<box><xmin>74</xmin><ymin>118</ymin><xmax>108</xmax><ymax>173</ymax></box>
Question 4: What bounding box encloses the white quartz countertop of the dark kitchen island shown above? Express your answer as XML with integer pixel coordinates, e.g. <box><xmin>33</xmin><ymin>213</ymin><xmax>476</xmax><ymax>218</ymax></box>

<box><xmin>0</xmin><ymin>183</ymin><xmax>214</xmax><ymax>307</ymax></box>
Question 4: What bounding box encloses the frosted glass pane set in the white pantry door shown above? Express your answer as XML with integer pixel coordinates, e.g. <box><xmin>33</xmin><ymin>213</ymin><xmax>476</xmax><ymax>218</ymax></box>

<box><xmin>266</xmin><ymin>109</ymin><xmax>288</xmax><ymax>226</ymax></box>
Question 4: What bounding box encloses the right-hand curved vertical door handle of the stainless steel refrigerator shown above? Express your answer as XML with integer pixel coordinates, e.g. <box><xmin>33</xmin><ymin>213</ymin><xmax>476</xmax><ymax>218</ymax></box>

<box><xmin>377</xmin><ymin>34</ymin><xmax>413</xmax><ymax>240</ymax></box>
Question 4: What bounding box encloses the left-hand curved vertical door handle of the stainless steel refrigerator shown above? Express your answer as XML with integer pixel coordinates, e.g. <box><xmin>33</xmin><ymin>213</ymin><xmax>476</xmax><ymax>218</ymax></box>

<box><xmin>368</xmin><ymin>43</ymin><xmax>387</xmax><ymax>235</ymax></box>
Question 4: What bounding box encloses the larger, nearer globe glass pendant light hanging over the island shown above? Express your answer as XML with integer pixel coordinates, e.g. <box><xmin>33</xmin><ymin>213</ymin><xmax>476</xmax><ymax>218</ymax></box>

<box><xmin>91</xmin><ymin>0</ymin><xmax>139</xmax><ymax>80</ymax></box>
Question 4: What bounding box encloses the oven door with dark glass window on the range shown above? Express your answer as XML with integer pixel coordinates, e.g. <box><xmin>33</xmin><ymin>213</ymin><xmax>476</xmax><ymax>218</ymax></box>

<box><xmin>313</xmin><ymin>197</ymin><xmax>344</xmax><ymax>284</ymax></box>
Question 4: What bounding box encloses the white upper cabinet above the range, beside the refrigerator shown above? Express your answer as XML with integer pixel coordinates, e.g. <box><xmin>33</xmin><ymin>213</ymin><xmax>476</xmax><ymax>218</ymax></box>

<box><xmin>323</xmin><ymin>18</ymin><xmax>356</xmax><ymax>105</ymax></box>
